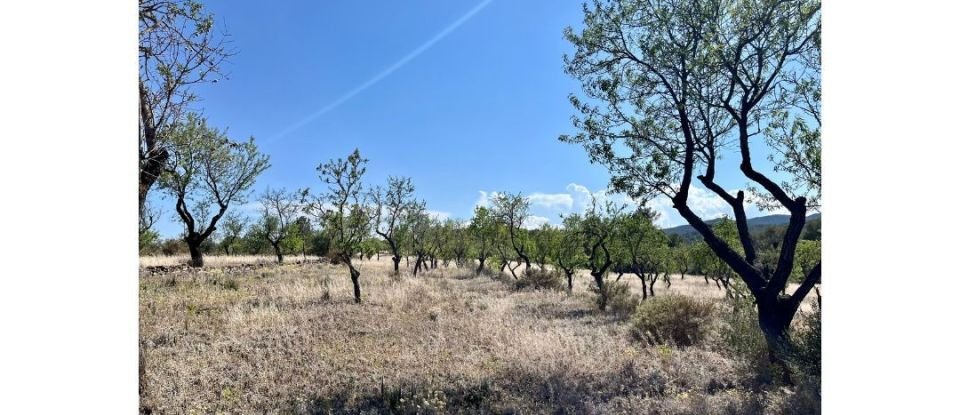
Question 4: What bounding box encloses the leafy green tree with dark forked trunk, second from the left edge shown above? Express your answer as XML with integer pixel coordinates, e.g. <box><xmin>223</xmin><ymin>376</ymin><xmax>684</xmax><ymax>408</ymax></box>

<box><xmin>160</xmin><ymin>115</ymin><xmax>269</xmax><ymax>267</ymax></box>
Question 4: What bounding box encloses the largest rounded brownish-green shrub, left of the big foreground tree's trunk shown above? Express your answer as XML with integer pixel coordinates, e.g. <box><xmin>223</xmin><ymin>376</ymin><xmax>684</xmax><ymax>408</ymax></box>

<box><xmin>631</xmin><ymin>295</ymin><xmax>713</xmax><ymax>347</ymax></box>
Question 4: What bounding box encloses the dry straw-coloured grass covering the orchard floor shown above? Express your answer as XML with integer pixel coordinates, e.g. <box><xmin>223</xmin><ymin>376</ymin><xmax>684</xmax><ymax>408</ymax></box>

<box><xmin>140</xmin><ymin>257</ymin><xmax>816</xmax><ymax>413</ymax></box>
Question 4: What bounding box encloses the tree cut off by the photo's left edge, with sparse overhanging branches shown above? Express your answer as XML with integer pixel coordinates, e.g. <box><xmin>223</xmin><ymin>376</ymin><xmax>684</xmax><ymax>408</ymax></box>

<box><xmin>138</xmin><ymin>0</ymin><xmax>230</xmax><ymax>219</ymax></box>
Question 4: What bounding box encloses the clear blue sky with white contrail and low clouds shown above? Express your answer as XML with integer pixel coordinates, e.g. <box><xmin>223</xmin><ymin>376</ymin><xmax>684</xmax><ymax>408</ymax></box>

<box><xmin>152</xmin><ymin>0</ymin><xmax>788</xmax><ymax>237</ymax></box>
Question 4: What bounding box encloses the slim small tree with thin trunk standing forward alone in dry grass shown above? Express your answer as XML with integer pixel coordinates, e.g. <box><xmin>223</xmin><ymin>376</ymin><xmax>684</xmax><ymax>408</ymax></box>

<box><xmin>301</xmin><ymin>150</ymin><xmax>373</xmax><ymax>304</ymax></box>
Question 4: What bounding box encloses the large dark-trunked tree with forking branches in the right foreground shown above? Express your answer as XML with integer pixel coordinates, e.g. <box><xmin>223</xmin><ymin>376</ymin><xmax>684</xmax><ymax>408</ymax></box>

<box><xmin>560</xmin><ymin>0</ymin><xmax>821</xmax><ymax>366</ymax></box>
